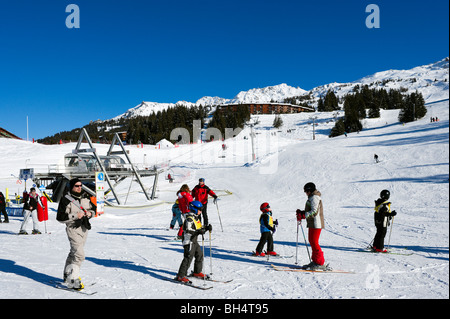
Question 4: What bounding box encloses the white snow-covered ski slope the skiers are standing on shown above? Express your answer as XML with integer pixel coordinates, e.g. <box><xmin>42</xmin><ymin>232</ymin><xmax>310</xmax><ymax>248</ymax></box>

<box><xmin>0</xmin><ymin>97</ymin><xmax>449</xmax><ymax>300</ymax></box>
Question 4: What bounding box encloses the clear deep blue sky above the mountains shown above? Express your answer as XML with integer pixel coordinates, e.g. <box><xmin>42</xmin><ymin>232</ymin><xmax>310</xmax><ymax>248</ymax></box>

<box><xmin>0</xmin><ymin>0</ymin><xmax>449</xmax><ymax>139</ymax></box>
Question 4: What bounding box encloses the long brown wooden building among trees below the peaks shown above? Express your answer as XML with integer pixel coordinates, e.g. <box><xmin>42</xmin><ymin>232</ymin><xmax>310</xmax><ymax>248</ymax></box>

<box><xmin>218</xmin><ymin>103</ymin><xmax>315</xmax><ymax>114</ymax></box>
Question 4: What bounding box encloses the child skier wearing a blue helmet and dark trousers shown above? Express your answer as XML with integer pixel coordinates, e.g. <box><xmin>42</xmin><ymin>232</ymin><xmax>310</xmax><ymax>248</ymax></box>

<box><xmin>175</xmin><ymin>201</ymin><xmax>212</xmax><ymax>283</ymax></box>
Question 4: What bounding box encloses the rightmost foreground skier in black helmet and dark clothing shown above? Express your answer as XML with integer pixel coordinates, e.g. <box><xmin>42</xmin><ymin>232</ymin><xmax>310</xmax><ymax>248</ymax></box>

<box><xmin>371</xmin><ymin>189</ymin><xmax>397</xmax><ymax>253</ymax></box>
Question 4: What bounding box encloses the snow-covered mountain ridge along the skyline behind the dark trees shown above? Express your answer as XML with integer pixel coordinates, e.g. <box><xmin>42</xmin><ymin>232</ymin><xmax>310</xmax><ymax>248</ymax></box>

<box><xmin>113</xmin><ymin>57</ymin><xmax>449</xmax><ymax>120</ymax></box>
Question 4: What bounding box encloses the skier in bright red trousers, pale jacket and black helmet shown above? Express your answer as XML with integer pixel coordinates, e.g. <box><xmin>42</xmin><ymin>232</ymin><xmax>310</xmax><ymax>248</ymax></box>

<box><xmin>297</xmin><ymin>183</ymin><xmax>327</xmax><ymax>270</ymax></box>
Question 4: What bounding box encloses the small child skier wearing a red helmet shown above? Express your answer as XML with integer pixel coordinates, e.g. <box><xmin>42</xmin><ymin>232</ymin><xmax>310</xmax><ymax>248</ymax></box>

<box><xmin>255</xmin><ymin>203</ymin><xmax>278</xmax><ymax>257</ymax></box>
